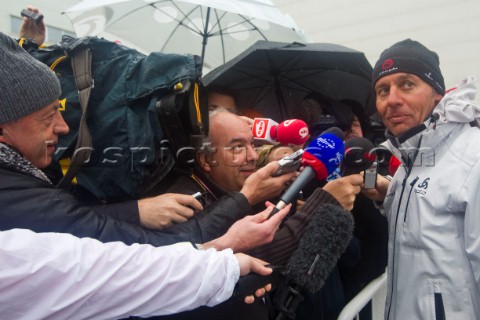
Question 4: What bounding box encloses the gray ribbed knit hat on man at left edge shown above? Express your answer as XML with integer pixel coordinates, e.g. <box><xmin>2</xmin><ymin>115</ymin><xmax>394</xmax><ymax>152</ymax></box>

<box><xmin>0</xmin><ymin>32</ymin><xmax>61</xmax><ymax>124</ymax></box>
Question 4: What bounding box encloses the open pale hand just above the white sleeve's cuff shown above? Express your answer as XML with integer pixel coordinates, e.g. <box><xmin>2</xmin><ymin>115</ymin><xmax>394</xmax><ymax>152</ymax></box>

<box><xmin>203</xmin><ymin>202</ymin><xmax>292</xmax><ymax>252</ymax></box>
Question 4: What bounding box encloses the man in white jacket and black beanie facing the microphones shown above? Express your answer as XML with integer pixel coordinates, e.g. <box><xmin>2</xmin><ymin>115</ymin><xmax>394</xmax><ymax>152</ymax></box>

<box><xmin>364</xmin><ymin>39</ymin><xmax>480</xmax><ymax>319</ymax></box>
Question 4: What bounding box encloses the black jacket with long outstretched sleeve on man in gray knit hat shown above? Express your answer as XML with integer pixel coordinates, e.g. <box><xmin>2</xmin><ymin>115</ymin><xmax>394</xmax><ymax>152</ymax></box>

<box><xmin>0</xmin><ymin>162</ymin><xmax>251</xmax><ymax>246</ymax></box>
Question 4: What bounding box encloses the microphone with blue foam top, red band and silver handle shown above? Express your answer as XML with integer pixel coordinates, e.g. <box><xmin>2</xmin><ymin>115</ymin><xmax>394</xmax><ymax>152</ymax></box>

<box><xmin>269</xmin><ymin>127</ymin><xmax>344</xmax><ymax>218</ymax></box>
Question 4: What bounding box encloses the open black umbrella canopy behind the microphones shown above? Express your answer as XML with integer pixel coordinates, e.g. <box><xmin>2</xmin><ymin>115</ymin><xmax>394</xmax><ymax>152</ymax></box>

<box><xmin>203</xmin><ymin>41</ymin><xmax>375</xmax><ymax>121</ymax></box>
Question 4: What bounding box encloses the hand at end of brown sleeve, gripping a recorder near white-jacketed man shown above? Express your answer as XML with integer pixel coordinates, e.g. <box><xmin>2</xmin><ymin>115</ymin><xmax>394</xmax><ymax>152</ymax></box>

<box><xmin>323</xmin><ymin>174</ymin><xmax>363</xmax><ymax>210</ymax></box>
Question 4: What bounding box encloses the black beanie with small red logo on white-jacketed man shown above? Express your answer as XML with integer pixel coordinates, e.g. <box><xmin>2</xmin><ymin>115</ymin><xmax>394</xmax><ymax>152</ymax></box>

<box><xmin>372</xmin><ymin>39</ymin><xmax>445</xmax><ymax>95</ymax></box>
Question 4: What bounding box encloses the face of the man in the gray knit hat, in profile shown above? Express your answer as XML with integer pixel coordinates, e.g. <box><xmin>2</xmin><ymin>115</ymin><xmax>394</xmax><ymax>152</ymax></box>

<box><xmin>0</xmin><ymin>100</ymin><xmax>69</xmax><ymax>169</ymax></box>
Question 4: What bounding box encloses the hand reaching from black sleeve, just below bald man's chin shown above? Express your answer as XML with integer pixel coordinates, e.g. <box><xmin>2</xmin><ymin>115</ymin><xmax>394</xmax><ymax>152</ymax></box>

<box><xmin>240</xmin><ymin>161</ymin><xmax>298</xmax><ymax>205</ymax></box>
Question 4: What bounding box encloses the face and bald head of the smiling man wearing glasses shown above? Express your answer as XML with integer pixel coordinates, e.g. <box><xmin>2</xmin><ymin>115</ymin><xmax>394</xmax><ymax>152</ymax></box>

<box><xmin>199</xmin><ymin>112</ymin><xmax>258</xmax><ymax>192</ymax></box>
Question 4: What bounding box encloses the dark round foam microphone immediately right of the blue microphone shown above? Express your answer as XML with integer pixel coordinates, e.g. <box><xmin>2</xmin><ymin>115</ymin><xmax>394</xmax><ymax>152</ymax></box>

<box><xmin>341</xmin><ymin>137</ymin><xmax>377</xmax><ymax>177</ymax></box>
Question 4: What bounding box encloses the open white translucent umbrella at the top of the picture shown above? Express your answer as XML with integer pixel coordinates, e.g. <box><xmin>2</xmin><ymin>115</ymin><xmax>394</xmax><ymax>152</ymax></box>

<box><xmin>64</xmin><ymin>0</ymin><xmax>305</xmax><ymax>70</ymax></box>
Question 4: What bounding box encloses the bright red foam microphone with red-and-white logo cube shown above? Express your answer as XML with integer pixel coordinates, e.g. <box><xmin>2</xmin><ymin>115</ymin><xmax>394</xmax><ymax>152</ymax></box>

<box><xmin>252</xmin><ymin>118</ymin><xmax>309</xmax><ymax>145</ymax></box>
